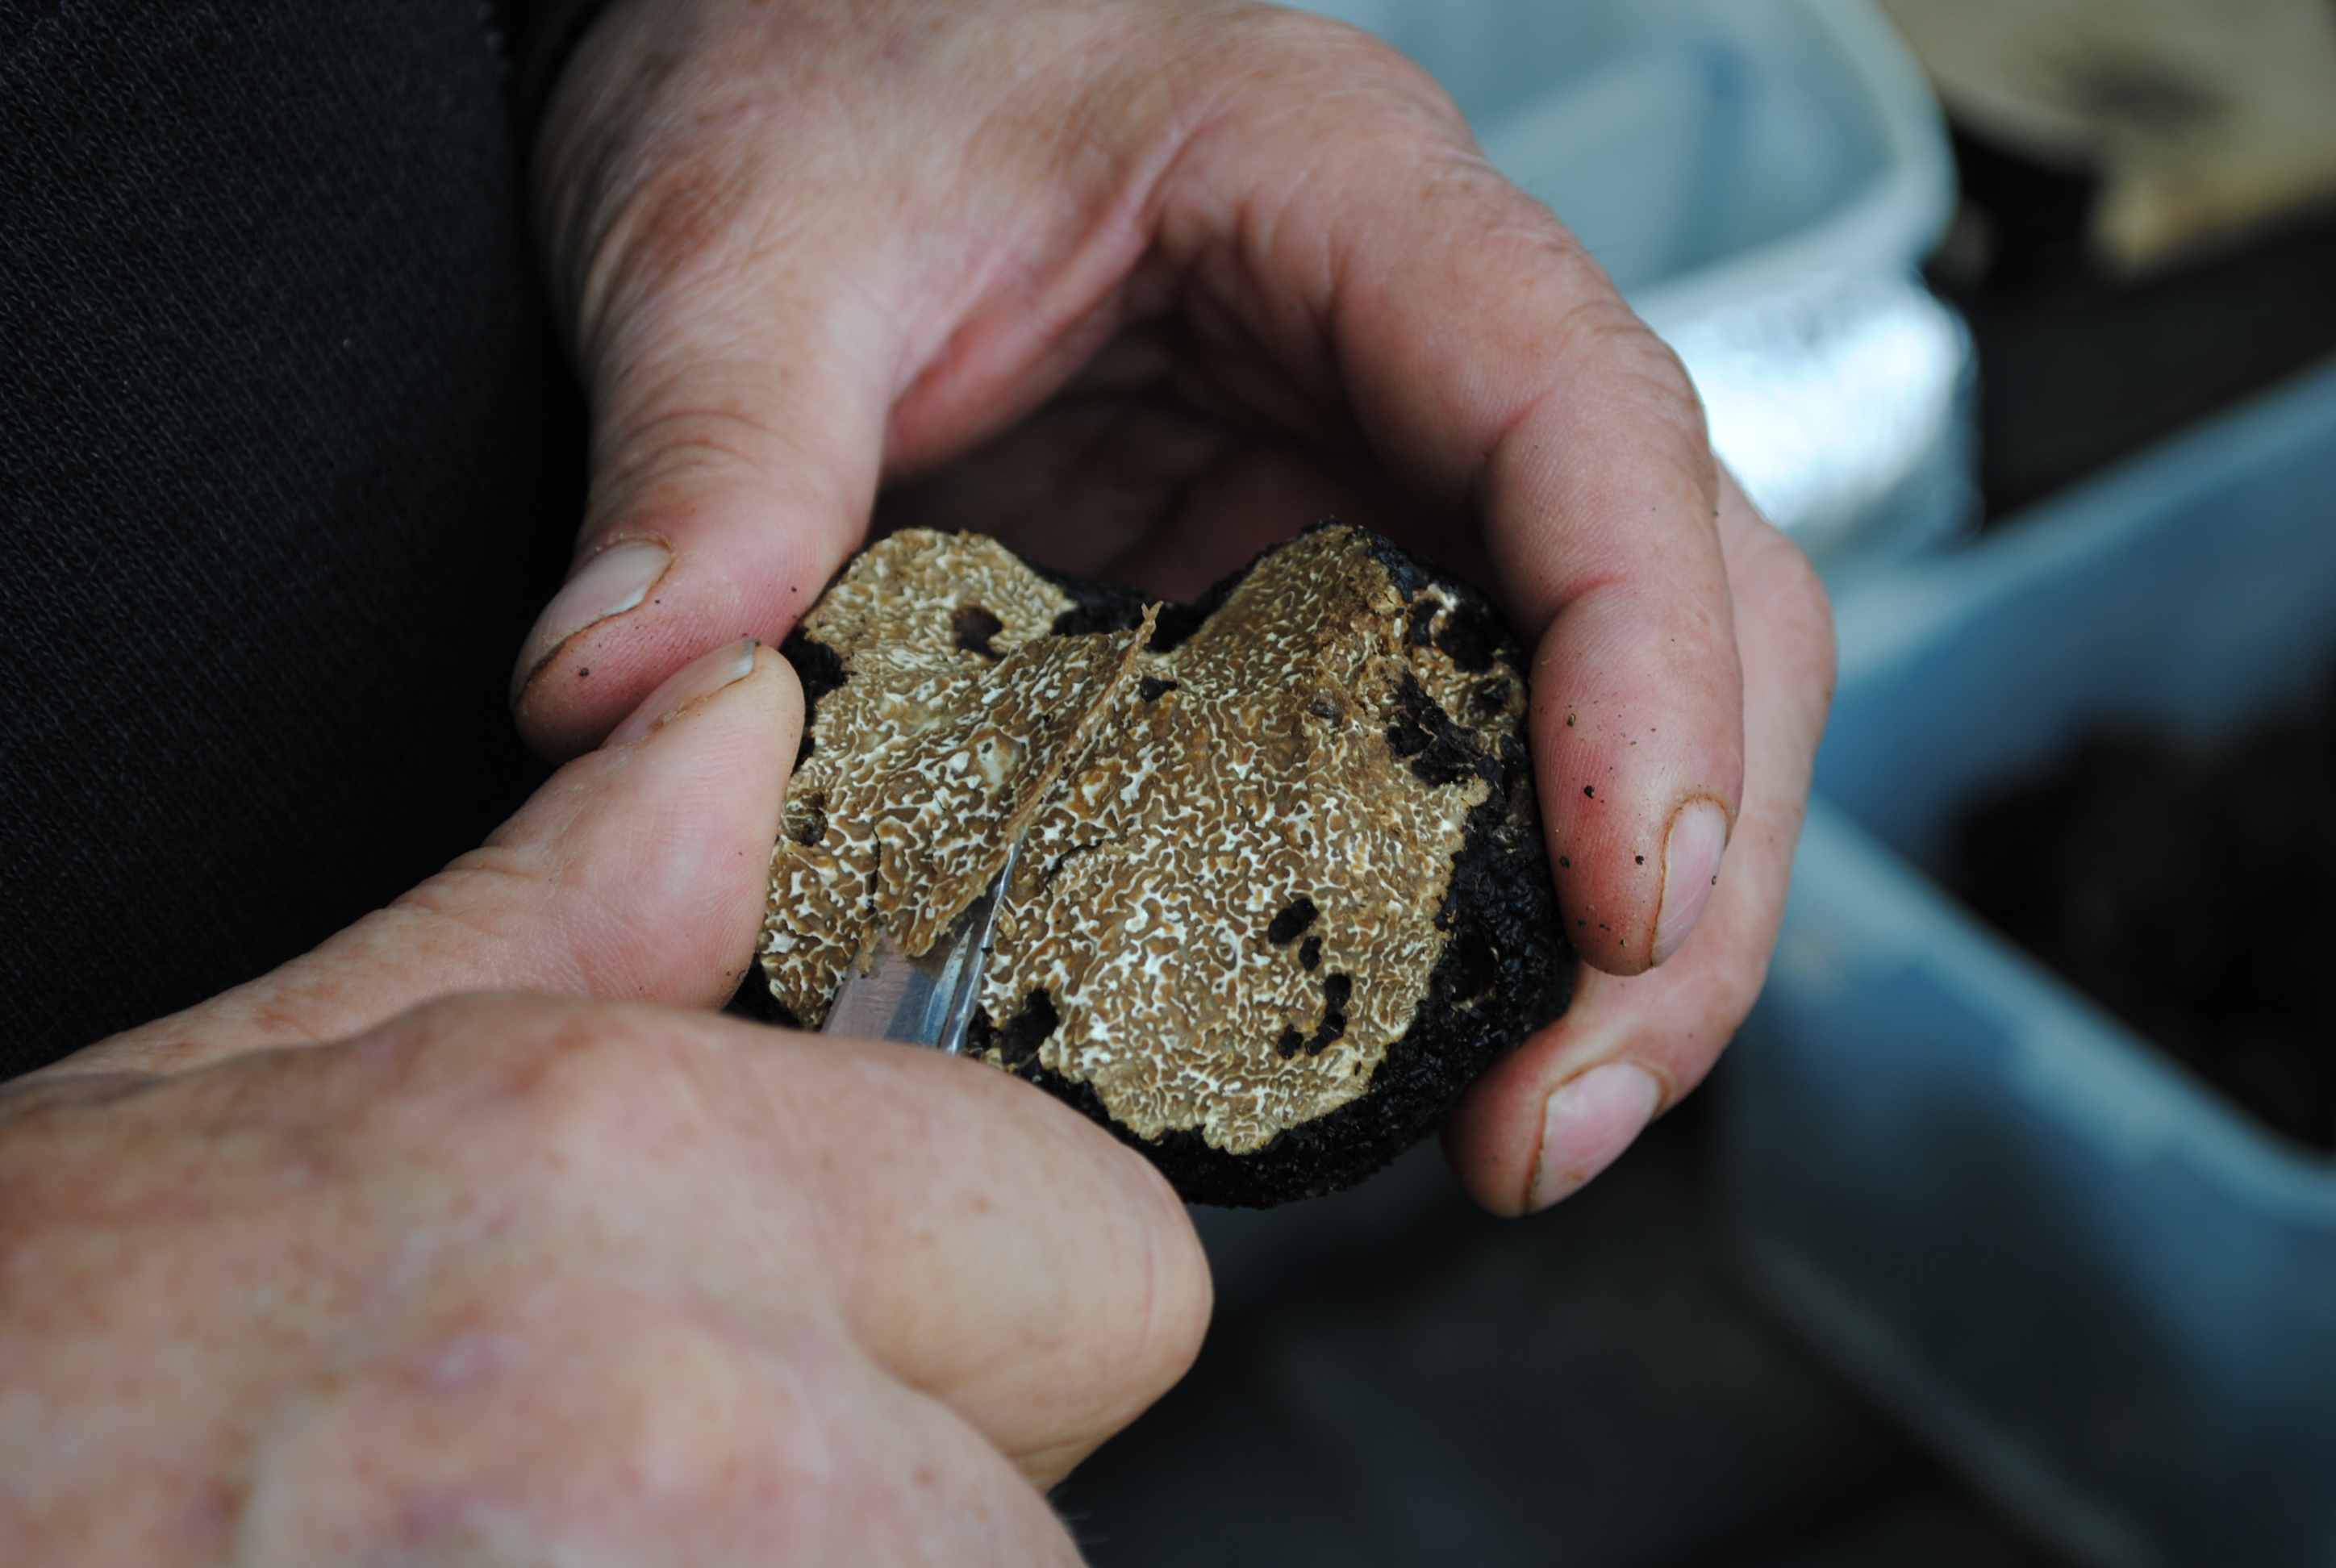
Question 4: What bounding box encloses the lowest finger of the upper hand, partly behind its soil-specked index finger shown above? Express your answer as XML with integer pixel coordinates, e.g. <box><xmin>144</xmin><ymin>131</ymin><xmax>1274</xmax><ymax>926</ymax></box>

<box><xmin>1446</xmin><ymin>482</ymin><xmax>1833</xmax><ymax>1216</ymax></box>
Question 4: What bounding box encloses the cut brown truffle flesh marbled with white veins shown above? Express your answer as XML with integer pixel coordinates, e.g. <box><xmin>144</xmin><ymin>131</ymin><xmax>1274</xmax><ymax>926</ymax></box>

<box><xmin>761</xmin><ymin>523</ymin><xmax>1572</xmax><ymax>1201</ymax></box>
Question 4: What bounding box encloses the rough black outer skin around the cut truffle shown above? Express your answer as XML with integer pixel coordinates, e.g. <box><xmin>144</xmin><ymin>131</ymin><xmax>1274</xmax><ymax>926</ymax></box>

<box><xmin>764</xmin><ymin>523</ymin><xmax>1577</xmax><ymax>1208</ymax></box>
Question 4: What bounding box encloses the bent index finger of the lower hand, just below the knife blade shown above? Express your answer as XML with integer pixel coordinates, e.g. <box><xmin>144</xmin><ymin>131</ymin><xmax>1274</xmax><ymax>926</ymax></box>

<box><xmin>340</xmin><ymin>998</ymin><xmax>1210</xmax><ymax>1479</ymax></box>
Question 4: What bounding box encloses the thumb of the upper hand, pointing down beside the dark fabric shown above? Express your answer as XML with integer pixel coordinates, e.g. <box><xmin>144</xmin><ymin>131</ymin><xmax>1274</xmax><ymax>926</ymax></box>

<box><xmin>511</xmin><ymin>73</ymin><xmax>899</xmax><ymax>757</ymax></box>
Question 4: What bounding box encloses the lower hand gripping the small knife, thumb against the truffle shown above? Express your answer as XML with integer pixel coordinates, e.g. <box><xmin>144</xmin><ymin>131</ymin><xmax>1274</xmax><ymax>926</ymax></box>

<box><xmin>0</xmin><ymin>645</ymin><xmax>1208</xmax><ymax>1566</ymax></box>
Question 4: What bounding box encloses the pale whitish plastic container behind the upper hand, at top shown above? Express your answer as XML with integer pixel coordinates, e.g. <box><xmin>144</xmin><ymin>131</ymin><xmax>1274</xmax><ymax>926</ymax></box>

<box><xmin>1313</xmin><ymin>0</ymin><xmax>1974</xmax><ymax>563</ymax></box>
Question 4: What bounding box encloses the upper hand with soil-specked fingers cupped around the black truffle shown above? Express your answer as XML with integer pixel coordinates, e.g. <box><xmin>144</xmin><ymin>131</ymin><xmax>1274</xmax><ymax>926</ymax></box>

<box><xmin>514</xmin><ymin>0</ymin><xmax>1831</xmax><ymax>1213</ymax></box>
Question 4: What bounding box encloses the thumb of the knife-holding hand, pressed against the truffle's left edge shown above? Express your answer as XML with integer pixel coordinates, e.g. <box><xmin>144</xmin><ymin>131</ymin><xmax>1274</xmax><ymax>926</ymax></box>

<box><xmin>52</xmin><ymin>643</ymin><xmax>803</xmax><ymax>1073</ymax></box>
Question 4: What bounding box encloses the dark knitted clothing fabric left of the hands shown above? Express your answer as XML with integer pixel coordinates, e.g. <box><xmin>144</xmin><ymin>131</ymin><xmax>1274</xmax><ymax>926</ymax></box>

<box><xmin>0</xmin><ymin>0</ymin><xmax>593</xmax><ymax>1075</ymax></box>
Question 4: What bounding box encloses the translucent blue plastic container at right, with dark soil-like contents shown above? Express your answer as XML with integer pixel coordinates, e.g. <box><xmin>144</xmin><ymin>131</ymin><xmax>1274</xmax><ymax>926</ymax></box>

<box><xmin>1719</xmin><ymin>367</ymin><xmax>2336</xmax><ymax>1566</ymax></box>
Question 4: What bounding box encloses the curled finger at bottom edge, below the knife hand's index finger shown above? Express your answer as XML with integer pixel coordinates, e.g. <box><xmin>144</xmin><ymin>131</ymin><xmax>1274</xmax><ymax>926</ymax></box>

<box><xmin>238</xmin><ymin>1292</ymin><xmax>1077</xmax><ymax>1568</ymax></box>
